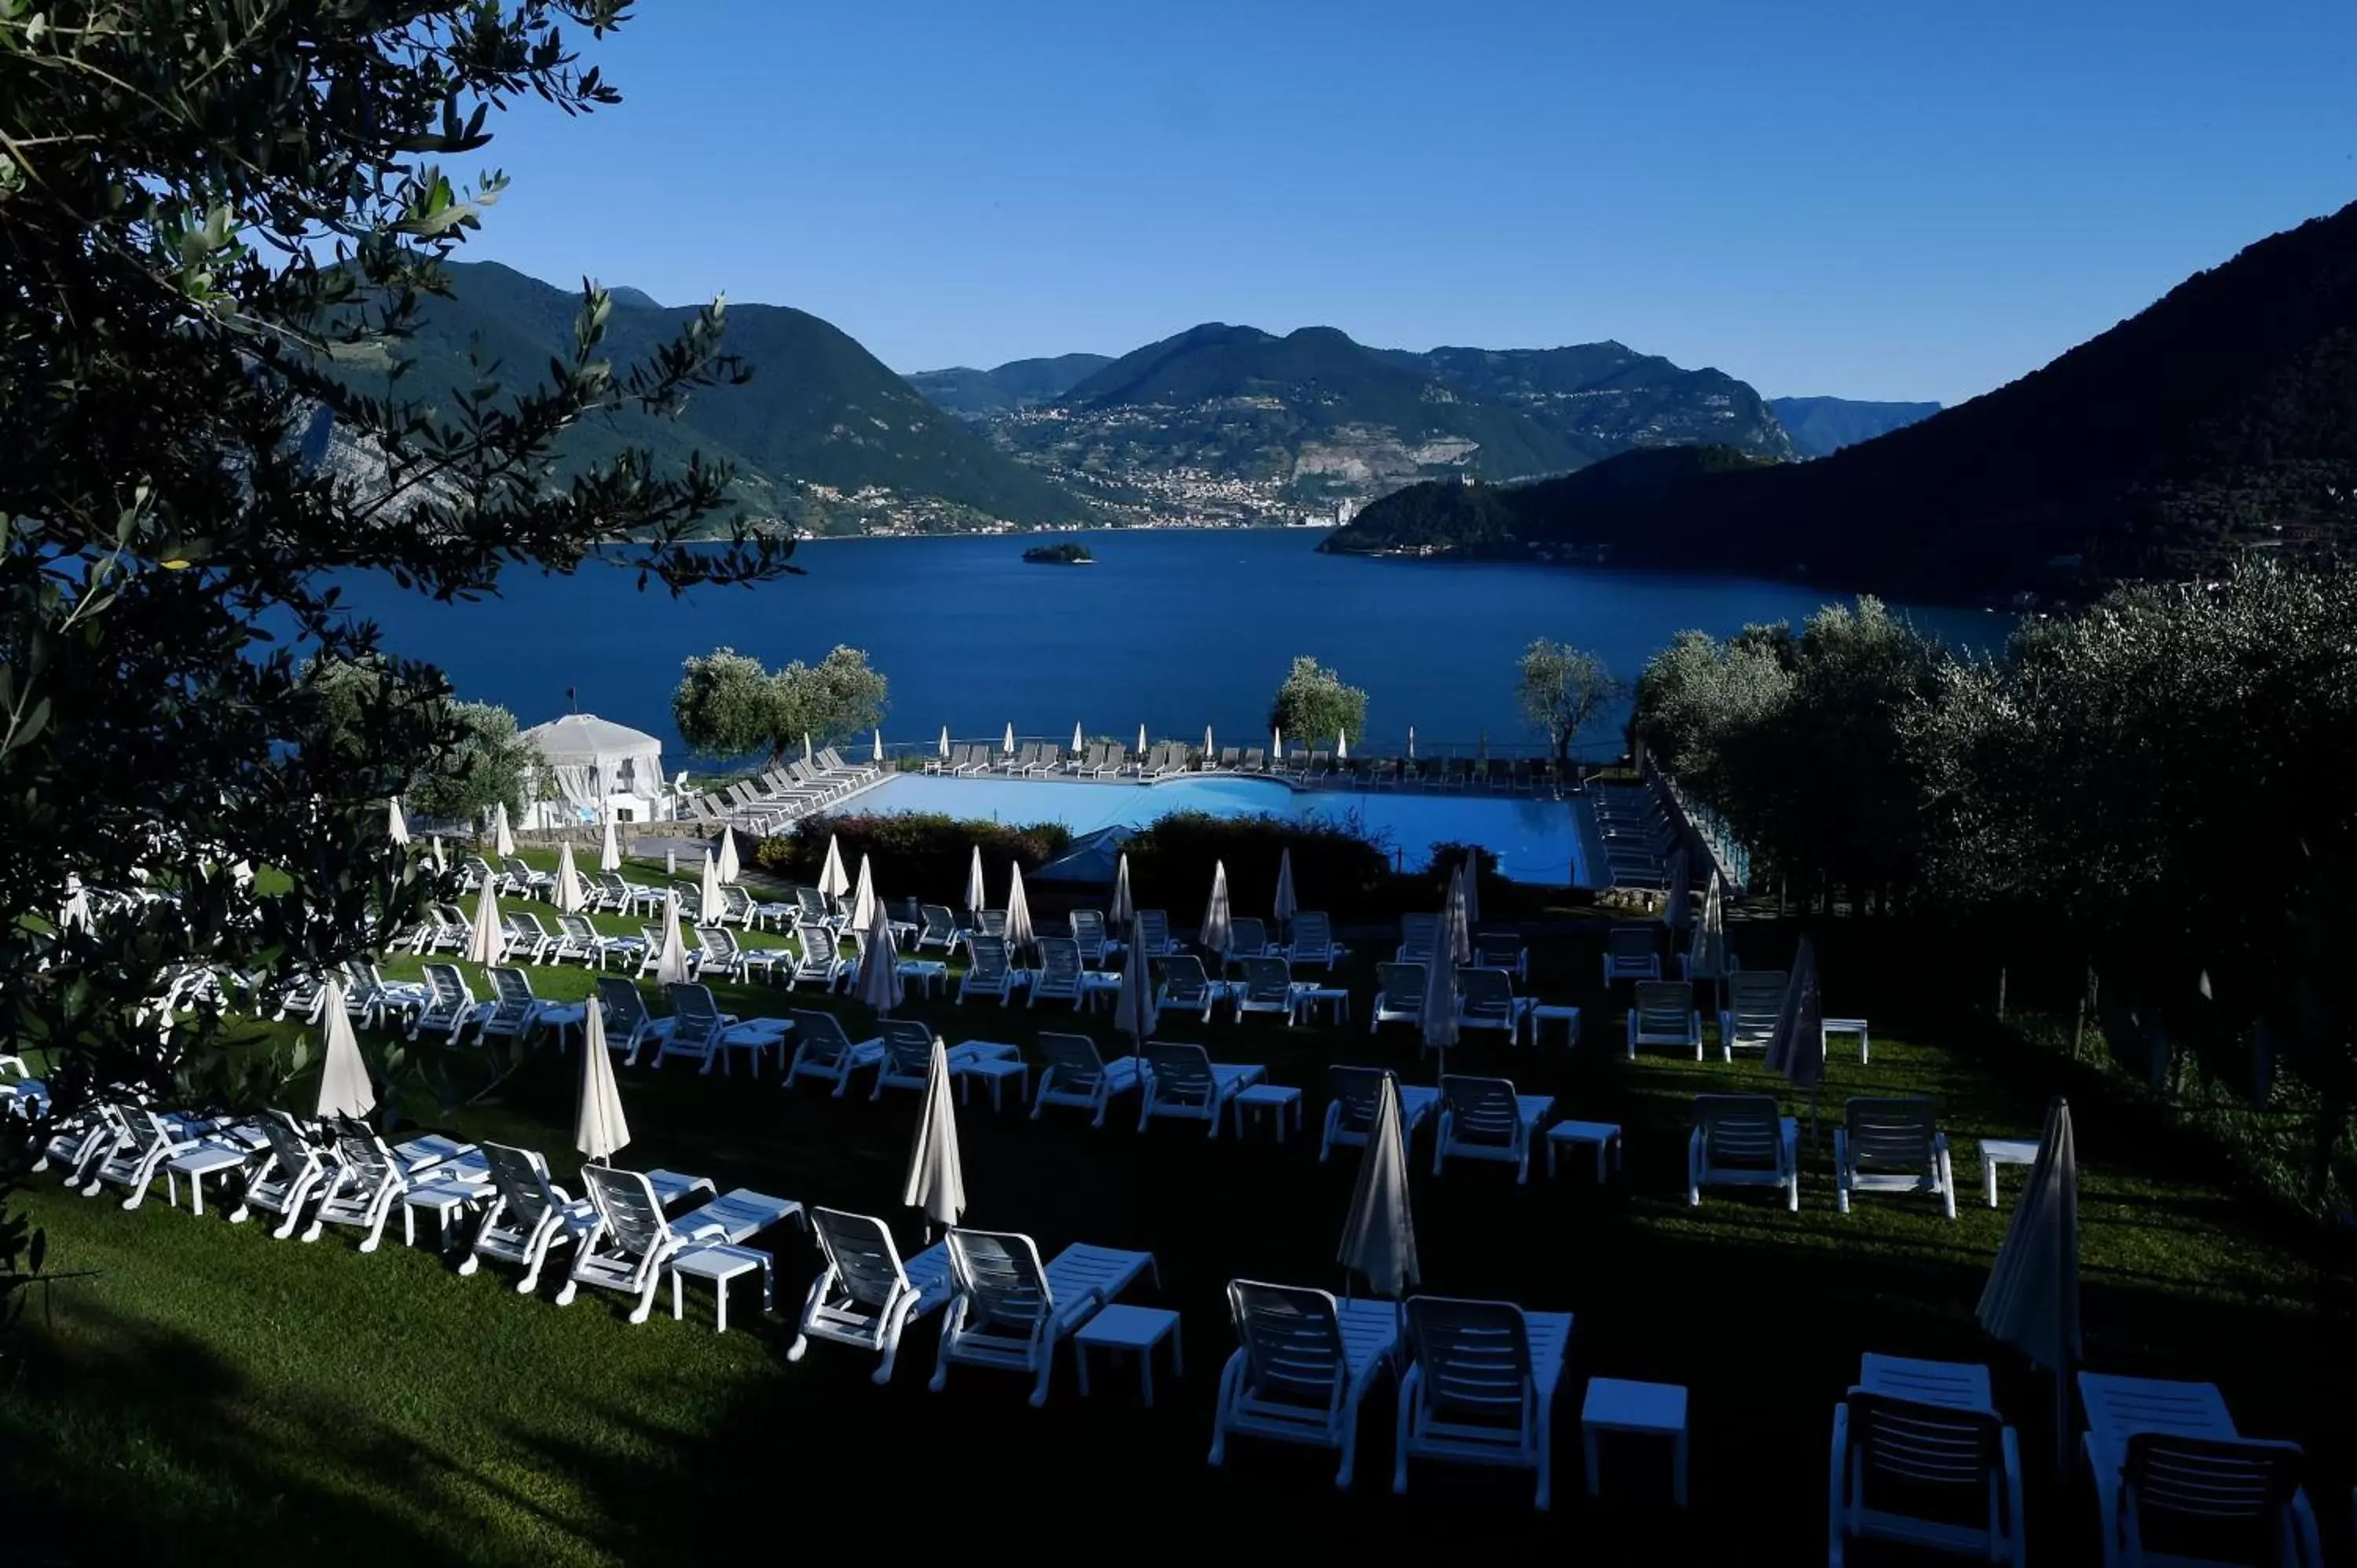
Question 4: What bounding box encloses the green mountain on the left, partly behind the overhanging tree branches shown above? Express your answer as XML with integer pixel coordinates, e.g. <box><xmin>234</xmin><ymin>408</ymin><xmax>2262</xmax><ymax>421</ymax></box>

<box><xmin>330</xmin><ymin>262</ymin><xmax>1089</xmax><ymax>530</ymax></box>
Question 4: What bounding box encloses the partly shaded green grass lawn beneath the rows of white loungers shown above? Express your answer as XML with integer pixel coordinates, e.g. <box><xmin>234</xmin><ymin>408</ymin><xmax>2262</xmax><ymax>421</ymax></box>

<box><xmin>0</xmin><ymin>858</ymin><xmax>2357</xmax><ymax>1566</ymax></box>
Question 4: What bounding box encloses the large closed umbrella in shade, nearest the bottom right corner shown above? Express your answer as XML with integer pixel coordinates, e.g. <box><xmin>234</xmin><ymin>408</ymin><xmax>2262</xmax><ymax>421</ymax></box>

<box><xmin>1978</xmin><ymin>1097</ymin><xmax>2081</xmax><ymax>1464</ymax></box>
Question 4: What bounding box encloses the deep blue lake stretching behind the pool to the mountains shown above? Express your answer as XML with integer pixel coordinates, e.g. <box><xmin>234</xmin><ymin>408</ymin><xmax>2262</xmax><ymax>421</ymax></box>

<box><xmin>328</xmin><ymin>528</ymin><xmax>2011</xmax><ymax>766</ymax></box>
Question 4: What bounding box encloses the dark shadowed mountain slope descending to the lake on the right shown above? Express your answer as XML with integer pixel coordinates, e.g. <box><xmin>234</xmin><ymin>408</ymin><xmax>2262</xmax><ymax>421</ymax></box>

<box><xmin>1327</xmin><ymin>205</ymin><xmax>2357</xmax><ymax>601</ymax></box>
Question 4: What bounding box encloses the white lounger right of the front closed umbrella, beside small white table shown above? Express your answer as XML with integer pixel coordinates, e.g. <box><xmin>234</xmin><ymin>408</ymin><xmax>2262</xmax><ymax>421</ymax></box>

<box><xmin>931</xmin><ymin>1229</ymin><xmax>1162</xmax><ymax>1408</ymax></box>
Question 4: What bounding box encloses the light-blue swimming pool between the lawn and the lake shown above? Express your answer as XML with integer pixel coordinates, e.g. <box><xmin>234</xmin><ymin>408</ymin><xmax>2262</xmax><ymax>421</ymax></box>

<box><xmin>839</xmin><ymin>773</ymin><xmax>1593</xmax><ymax>887</ymax></box>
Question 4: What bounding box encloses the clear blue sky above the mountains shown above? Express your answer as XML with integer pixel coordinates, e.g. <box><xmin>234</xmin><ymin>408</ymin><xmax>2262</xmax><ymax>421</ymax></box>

<box><xmin>469</xmin><ymin>0</ymin><xmax>2357</xmax><ymax>401</ymax></box>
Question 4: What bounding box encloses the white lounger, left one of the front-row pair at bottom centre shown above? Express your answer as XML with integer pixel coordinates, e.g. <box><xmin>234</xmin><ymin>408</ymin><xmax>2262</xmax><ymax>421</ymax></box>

<box><xmin>1211</xmin><ymin>1280</ymin><xmax>1400</xmax><ymax>1488</ymax></box>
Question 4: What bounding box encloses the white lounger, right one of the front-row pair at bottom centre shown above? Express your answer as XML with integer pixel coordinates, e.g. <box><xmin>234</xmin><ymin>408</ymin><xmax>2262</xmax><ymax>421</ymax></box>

<box><xmin>1391</xmin><ymin>1297</ymin><xmax>1572</xmax><ymax>1509</ymax></box>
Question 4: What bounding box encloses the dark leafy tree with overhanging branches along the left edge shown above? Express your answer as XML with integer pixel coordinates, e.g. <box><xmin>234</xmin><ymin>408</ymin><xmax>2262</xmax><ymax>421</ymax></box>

<box><xmin>0</xmin><ymin>0</ymin><xmax>790</xmax><ymax>1302</ymax></box>
